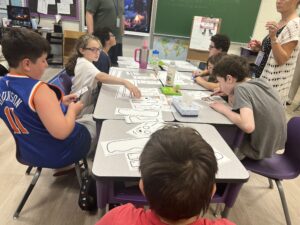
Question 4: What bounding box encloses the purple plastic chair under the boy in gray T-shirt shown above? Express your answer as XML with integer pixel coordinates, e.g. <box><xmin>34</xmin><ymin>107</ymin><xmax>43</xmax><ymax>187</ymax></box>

<box><xmin>242</xmin><ymin>117</ymin><xmax>300</xmax><ymax>225</ymax></box>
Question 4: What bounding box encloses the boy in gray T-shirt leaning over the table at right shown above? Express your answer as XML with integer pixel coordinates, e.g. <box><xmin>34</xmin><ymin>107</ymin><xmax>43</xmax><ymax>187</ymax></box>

<box><xmin>210</xmin><ymin>55</ymin><xmax>287</xmax><ymax>160</ymax></box>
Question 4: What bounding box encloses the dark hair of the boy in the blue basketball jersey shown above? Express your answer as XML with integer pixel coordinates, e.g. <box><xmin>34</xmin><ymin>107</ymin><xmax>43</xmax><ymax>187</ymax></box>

<box><xmin>2</xmin><ymin>28</ymin><xmax>50</xmax><ymax>68</ymax></box>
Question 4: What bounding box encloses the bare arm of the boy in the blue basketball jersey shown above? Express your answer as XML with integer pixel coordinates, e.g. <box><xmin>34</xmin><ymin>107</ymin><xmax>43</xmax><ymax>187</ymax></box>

<box><xmin>33</xmin><ymin>84</ymin><xmax>83</xmax><ymax>140</ymax></box>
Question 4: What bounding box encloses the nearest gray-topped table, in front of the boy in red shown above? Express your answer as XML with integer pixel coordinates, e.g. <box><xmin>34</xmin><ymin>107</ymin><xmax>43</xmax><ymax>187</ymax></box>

<box><xmin>92</xmin><ymin>120</ymin><xmax>249</xmax><ymax>216</ymax></box>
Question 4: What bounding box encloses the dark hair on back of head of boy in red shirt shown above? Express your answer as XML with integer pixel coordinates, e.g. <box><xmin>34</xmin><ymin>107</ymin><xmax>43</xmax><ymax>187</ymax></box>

<box><xmin>140</xmin><ymin>127</ymin><xmax>218</xmax><ymax>221</ymax></box>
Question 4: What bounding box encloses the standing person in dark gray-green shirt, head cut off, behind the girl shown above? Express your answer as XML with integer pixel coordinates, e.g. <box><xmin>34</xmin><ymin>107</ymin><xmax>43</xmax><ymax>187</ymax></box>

<box><xmin>86</xmin><ymin>0</ymin><xmax>124</xmax><ymax>65</ymax></box>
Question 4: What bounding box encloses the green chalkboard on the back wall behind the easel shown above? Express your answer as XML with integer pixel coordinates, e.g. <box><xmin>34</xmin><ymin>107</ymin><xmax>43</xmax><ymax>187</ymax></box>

<box><xmin>155</xmin><ymin>0</ymin><xmax>261</xmax><ymax>43</ymax></box>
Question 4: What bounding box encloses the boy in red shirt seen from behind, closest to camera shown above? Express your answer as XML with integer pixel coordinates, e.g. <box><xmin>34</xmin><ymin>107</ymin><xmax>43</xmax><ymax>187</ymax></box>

<box><xmin>96</xmin><ymin>127</ymin><xmax>233</xmax><ymax>225</ymax></box>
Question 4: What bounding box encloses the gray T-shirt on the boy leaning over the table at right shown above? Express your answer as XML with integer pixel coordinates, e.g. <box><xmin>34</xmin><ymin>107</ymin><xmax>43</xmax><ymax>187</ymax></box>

<box><xmin>233</xmin><ymin>78</ymin><xmax>287</xmax><ymax>159</ymax></box>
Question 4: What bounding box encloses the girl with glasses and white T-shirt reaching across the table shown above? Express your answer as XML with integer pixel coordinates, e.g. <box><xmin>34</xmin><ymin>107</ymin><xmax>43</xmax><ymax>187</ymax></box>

<box><xmin>66</xmin><ymin>34</ymin><xmax>141</xmax><ymax>116</ymax></box>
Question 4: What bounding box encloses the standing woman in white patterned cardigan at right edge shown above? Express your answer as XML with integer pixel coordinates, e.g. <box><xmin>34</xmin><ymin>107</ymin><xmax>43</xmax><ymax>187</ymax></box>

<box><xmin>249</xmin><ymin>0</ymin><xmax>300</xmax><ymax>103</ymax></box>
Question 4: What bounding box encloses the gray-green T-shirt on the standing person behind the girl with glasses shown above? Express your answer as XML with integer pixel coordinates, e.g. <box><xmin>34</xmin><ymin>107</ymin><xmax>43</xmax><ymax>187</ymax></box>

<box><xmin>86</xmin><ymin>0</ymin><xmax>124</xmax><ymax>43</ymax></box>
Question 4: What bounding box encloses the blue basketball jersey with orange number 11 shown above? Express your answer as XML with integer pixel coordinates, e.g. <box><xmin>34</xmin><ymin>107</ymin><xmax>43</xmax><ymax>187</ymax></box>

<box><xmin>0</xmin><ymin>74</ymin><xmax>90</xmax><ymax>168</ymax></box>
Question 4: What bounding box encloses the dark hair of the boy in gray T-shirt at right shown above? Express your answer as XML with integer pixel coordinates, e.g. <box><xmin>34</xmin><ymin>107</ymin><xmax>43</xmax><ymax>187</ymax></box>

<box><xmin>213</xmin><ymin>55</ymin><xmax>249</xmax><ymax>82</ymax></box>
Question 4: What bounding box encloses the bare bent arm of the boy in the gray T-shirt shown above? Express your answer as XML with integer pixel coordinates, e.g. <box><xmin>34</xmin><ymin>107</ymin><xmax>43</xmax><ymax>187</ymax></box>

<box><xmin>210</xmin><ymin>102</ymin><xmax>255</xmax><ymax>134</ymax></box>
